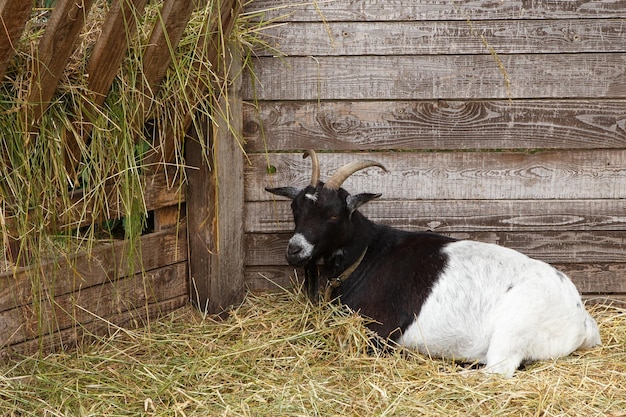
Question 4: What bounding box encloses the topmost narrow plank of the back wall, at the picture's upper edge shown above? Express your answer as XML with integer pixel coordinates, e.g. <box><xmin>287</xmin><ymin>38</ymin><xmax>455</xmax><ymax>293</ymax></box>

<box><xmin>246</xmin><ymin>0</ymin><xmax>626</xmax><ymax>22</ymax></box>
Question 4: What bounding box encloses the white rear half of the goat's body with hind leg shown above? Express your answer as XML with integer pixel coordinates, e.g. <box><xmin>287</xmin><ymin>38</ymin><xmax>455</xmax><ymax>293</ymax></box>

<box><xmin>399</xmin><ymin>241</ymin><xmax>600</xmax><ymax>376</ymax></box>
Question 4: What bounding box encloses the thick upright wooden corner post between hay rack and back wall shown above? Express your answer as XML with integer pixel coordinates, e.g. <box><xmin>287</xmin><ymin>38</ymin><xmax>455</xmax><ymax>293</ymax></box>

<box><xmin>185</xmin><ymin>44</ymin><xmax>244</xmax><ymax>313</ymax></box>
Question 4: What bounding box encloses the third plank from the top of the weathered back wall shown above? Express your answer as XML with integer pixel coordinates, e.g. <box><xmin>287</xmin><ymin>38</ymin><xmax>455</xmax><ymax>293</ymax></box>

<box><xmin>243</xmin><ymin>53</ymin><xmax>626</xmax><ymax>101</ymax></box>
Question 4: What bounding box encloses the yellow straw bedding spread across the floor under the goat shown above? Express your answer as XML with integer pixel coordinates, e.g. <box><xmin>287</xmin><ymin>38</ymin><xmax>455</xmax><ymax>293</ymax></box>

<box><xmin>0</xmin><ymin>286</ymin><xmax>626</xmax><ymax>417</ymax></box>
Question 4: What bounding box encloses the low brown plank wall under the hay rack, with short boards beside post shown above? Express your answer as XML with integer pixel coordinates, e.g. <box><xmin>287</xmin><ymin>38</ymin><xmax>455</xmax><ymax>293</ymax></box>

<box><xmin>0</xmin><ymin>172</ymin><xmax>189</xmax><ymax>361</ymax></box>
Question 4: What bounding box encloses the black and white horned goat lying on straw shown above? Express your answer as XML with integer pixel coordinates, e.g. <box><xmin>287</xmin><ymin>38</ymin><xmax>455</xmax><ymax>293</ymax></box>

<box><xmin>266</xmin><ymin>151</ymin><xmax>601</xmax><ymax>376</ymax></box>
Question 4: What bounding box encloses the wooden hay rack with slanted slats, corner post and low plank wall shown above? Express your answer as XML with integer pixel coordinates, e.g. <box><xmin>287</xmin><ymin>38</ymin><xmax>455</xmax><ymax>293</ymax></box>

<box><xmin>0</xmin><ymin>0</ymin><xmax>243</xmax><ymax>361</ymax></box>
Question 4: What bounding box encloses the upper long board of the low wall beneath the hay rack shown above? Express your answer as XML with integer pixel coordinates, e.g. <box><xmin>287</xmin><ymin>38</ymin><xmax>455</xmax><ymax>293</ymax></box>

<box><xmin>0</xmin><ymin>229</ymin><xmax>187</xmax><ymax>311</ymax></box>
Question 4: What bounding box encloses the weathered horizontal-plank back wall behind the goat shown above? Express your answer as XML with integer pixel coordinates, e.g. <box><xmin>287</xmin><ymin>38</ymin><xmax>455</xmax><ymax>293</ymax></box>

<box><xmin>243</xmin><ymin>0</ymin><xmax>626</xmax><ymax>300</ymax></box>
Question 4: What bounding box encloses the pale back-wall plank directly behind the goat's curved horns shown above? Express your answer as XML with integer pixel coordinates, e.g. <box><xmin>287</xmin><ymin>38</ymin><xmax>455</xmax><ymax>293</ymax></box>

<box><xmin>245</xmin><ymin>149</ymin><xmax>626</xmax><ymax>201</ymax></box>
